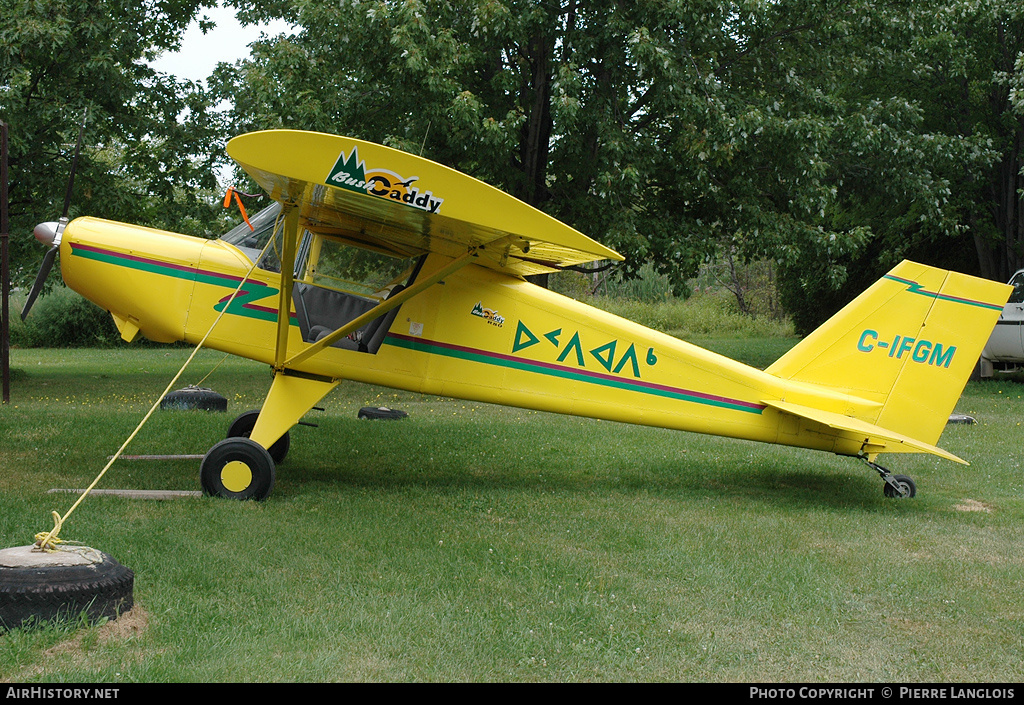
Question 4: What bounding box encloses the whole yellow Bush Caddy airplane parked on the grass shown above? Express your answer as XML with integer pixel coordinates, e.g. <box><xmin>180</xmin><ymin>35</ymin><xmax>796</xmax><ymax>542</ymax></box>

<box><xmin>19</xmin><ymin>130</ymin><xmax>1012</xmax><ymax>499</ymax></box>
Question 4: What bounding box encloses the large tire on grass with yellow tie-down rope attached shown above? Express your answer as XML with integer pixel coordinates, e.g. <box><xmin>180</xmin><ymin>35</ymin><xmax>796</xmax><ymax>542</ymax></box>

<box><xmin>0</xmin><ymin>546</ymin><xmax>135</xmax><ymax>629</ymax></box>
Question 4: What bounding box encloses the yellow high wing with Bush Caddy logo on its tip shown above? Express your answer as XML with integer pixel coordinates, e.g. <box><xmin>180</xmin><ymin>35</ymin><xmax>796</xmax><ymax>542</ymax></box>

<box><xmin>227</xmin><ymin>130</ymin><xmax>623</xmax><ymax>276</ymax></box>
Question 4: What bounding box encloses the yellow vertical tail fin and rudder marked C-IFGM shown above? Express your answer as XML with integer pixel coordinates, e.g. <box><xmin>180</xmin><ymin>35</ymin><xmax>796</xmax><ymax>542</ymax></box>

<box><xmin>767</xmin><ymin>261</ymin><xmax>1012</xmax><ymax>444</ymax></box>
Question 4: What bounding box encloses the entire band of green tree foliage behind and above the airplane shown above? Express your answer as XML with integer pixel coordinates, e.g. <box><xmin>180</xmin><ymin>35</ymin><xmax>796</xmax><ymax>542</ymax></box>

<box><xmin>0</xmin><ymin>0</ymin><xmax>1024</xmax><ymax>342</ymax></box>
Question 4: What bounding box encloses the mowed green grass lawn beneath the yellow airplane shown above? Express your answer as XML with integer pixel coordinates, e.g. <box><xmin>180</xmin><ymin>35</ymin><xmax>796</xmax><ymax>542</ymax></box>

<box><xmin>0</xmin><ymin>340</ymin><xmax>1024</xmax><ymax>682</ymax></box>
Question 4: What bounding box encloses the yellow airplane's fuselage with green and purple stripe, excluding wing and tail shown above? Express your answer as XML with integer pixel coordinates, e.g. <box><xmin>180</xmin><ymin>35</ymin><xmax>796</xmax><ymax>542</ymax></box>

<box><xmin>60</xmin><ymin>218</ymin><xmax>888</xmax><ymax>455</ymax></box>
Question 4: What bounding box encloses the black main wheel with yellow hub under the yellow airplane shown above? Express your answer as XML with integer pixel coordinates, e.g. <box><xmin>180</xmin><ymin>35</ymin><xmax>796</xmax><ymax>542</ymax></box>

<box><xmin>199</xmin><ymin>438</ymin><xmax>274</xmax><ymax>501</ymax></box>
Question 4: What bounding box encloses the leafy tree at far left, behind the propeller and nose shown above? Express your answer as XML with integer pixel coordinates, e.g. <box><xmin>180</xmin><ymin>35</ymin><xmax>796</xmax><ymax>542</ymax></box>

<box><xmin>0</xmin><ymin>0</ymin><xmax>230</xmax><ymax>282</ymax></box>
